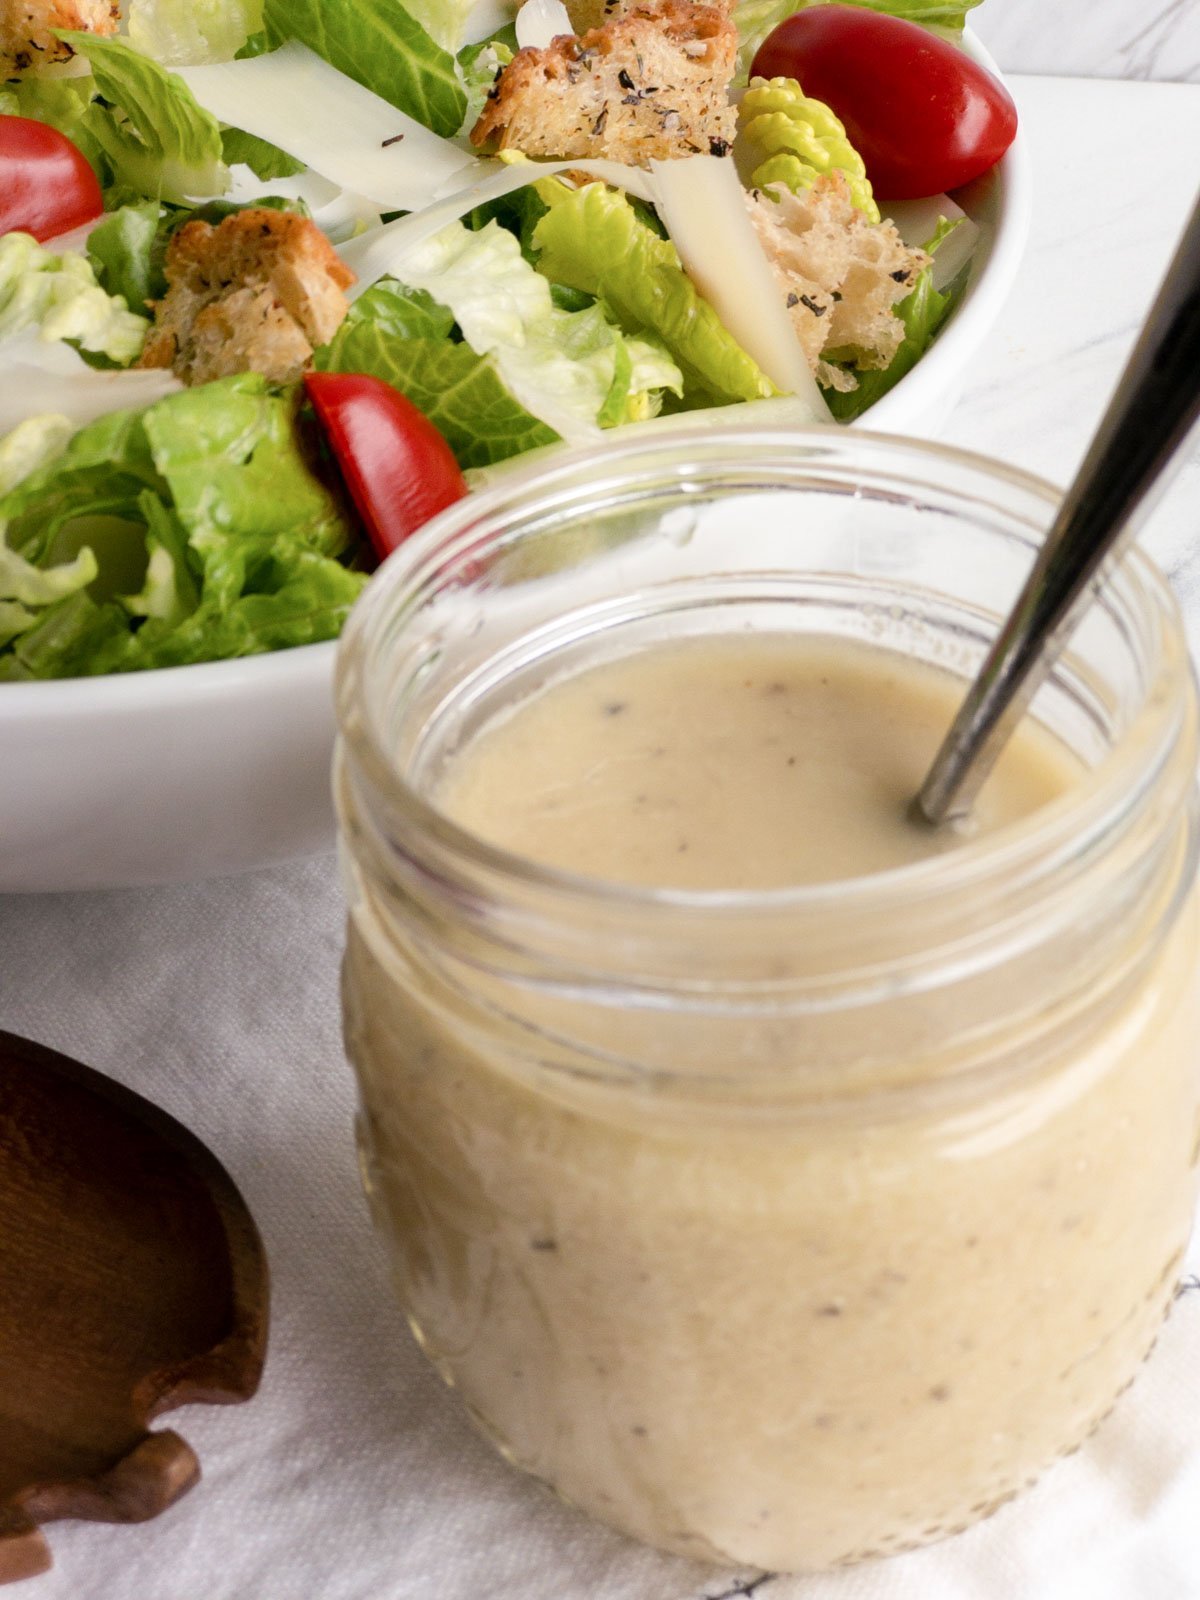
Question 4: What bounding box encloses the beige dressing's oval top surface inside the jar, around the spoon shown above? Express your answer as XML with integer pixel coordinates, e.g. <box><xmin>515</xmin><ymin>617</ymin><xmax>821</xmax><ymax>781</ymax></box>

<box><xmin>437</xmin><ymin>634</ymin><xmax>1078</xmax><ymax>890</ymax></box>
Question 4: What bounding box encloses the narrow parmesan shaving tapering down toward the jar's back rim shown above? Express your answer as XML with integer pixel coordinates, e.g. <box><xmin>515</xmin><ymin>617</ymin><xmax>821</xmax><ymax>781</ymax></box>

<box><xmin>650</xmin><ymin>155</ymin><xmax>832</xmax><ymax>422</ymax></box>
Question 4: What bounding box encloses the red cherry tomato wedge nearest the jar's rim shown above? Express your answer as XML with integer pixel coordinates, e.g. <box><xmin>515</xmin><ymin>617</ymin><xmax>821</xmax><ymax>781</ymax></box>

<box><xmin>304</xmin><ymin>373</ymin><xmax>467</xmax><ymax>560</ymax></box>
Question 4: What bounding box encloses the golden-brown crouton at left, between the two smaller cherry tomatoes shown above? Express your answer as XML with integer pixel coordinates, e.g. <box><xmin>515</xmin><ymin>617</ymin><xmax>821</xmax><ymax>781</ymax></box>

<box><xmin>138</xmin><ymin>208</ymin><xmax>354</xmax><ymax>384</ymax></box>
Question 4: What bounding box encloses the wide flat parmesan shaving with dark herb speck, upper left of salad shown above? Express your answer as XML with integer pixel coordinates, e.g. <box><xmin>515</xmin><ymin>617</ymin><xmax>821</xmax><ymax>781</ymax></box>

<box><xmin>176</xmin><ymin>40</ymin><xmax>477</xmax><ymax>211</ymax></box>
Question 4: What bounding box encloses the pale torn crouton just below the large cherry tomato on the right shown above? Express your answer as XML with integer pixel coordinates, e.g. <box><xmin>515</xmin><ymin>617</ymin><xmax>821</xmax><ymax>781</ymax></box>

<box><xmin>747</xmin><ymin>171</ymin><xmax>930</xmax><ymax>389</ymax></box>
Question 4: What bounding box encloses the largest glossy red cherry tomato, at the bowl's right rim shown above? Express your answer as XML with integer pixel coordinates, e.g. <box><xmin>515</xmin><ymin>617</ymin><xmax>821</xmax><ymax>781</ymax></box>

<box><xmin>750</xmin><ymin>5</ymin><xmax>1016</xmax><ymax>200</ymax></box>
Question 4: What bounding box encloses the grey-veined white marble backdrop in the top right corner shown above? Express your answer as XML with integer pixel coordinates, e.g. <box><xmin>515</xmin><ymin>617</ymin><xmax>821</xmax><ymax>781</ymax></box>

<box><xmin>971</xmin><ymin>0</ymin><xmax>1200</xmax><ymax>84</ymax></box>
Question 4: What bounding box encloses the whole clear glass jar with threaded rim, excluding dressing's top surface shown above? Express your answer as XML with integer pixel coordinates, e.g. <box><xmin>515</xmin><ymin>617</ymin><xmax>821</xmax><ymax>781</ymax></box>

<box><xmin>338</xmin><ymin>430</ymin><xmax>1200</xmax><ymax>1570</ymax></box>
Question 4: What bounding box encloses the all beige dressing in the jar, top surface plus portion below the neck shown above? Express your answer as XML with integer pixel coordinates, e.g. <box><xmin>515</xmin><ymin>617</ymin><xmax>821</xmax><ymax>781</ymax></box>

<box><xmin>346</xmin><ymin>637</ymin><xmax>1200</xmax><ymax>1570</ymax></box>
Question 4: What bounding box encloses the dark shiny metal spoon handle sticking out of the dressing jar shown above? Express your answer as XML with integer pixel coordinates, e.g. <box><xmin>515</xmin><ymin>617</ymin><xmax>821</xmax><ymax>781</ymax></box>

<box><xmin>914</xmin><ymin>190</ymin><xmax>1200</xmax><ymax>824</ymax></box>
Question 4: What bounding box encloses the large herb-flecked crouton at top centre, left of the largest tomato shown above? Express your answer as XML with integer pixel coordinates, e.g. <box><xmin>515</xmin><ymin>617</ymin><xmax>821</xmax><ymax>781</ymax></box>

<box><xmin>470</xmin><ymin>0</ymin><xmax>738</xmax><ymax>163</ymax></box>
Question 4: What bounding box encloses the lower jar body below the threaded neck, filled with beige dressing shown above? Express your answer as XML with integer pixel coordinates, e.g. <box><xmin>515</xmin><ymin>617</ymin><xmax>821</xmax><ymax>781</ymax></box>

<box><xmin>346</xmin><ymin>907</ymin><xmax>1200</xmax><ymax>1571</ymax></box>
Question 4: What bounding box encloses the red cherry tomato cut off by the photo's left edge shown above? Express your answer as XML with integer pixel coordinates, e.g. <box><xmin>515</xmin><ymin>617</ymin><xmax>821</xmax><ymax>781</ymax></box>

<box><xmin>0</xmin><ymin>117</ymin><xmax>104</xmax><ymax>243</ymax></box>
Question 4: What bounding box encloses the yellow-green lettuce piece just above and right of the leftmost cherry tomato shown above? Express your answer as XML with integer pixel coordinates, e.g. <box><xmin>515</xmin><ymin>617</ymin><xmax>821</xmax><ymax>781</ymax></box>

<box><xmin>58</xmin><ymin>30</ymin><xmax>229</xmax><ymax>202</ymax></box>
